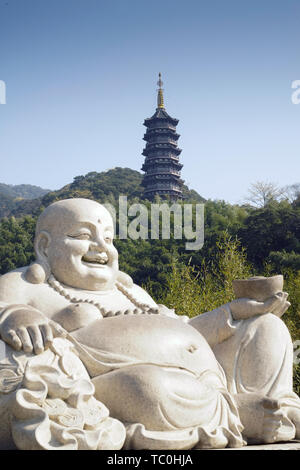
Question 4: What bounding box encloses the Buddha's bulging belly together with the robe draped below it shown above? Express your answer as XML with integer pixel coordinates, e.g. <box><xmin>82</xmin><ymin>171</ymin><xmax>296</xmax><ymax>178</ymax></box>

<box><xmin>72</xmin><ymin>315</ymin><xmax>243</xmax><ymax>449</ymax></box>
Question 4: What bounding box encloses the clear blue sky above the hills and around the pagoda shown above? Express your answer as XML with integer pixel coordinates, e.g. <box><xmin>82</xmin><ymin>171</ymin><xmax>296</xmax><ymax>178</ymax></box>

<box><xmin>0</xmin><ymin>0</ymin><xmax>300</xmax><ymax>203</ymax></box>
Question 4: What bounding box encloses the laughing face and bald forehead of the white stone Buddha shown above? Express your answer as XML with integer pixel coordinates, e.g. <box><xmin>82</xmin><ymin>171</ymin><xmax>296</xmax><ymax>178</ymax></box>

<box><xmin>41</xmin><ymin>199</ymin><xmax>118</xmax><ymax>291</ymax></box>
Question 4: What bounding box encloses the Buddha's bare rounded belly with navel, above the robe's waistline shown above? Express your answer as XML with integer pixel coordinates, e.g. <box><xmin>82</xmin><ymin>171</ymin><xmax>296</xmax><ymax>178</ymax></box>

<box><xmin>72</xmin><ymin>315</ymin><xmax>220</xmax><ymax>374</ymax></box>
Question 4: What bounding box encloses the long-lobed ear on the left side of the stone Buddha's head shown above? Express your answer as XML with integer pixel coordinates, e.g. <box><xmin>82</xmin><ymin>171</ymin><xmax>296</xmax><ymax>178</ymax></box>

<box><xmin>25</xmin><ymin>231</ymin><xmax>51</xmax><ymax>284</ymax></box>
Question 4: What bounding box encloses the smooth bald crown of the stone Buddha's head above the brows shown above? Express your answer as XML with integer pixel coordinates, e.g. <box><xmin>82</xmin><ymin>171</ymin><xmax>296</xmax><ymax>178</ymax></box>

<box><xmin>36</xmin><ymin>198</ymin><xmax>113</xmax><ymax>236</ymax></box>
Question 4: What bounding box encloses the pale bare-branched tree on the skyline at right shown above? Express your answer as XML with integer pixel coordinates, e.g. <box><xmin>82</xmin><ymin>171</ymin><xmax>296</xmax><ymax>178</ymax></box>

<box><xmin>246</xmin><ymin>181</ymin><xmax>285</xmax><ymax>207</ymax></box>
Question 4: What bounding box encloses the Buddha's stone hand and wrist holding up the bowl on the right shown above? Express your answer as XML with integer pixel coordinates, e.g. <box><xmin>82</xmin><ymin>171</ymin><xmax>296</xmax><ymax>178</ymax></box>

<box><xmin>229</xmin><ymin>292</ymin><xmax>291</xmax><ymax>320</ymax></box>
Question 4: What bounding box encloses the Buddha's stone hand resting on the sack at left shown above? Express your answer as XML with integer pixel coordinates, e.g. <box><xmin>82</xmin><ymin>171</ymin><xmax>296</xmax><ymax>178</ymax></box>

<box><xmin>0</xmin><ymin>305</ymin><xmax>53</xmax><ymax>354</ymax></box>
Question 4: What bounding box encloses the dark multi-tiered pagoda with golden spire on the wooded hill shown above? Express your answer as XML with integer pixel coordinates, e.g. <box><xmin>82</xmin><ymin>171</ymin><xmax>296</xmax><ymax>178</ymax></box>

<box><xmin>142</xmin><ymin>74</ymin><xmax>183</xmax><ymax>201</ymax></box>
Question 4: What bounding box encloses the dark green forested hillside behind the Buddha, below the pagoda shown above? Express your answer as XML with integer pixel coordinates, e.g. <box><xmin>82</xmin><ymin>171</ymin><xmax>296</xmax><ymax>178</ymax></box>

<box><xmin>0</xmin><ymin>168</ymin><xmax>300</xmax><ymax>289</ymax></box>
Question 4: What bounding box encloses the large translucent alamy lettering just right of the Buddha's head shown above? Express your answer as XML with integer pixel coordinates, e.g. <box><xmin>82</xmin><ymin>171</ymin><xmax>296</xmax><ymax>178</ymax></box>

<box><xmin>103</xmin><ymin>196</ymin><xmax>204</xmax><ymax>250</ymax></box>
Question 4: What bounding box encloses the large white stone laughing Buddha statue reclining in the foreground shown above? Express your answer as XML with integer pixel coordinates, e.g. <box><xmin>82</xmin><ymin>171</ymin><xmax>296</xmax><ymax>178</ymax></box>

<box><xmin>0</xmin><ymin>199</ymin><xmax>300</xmax><ymax>449</ymax></box>
